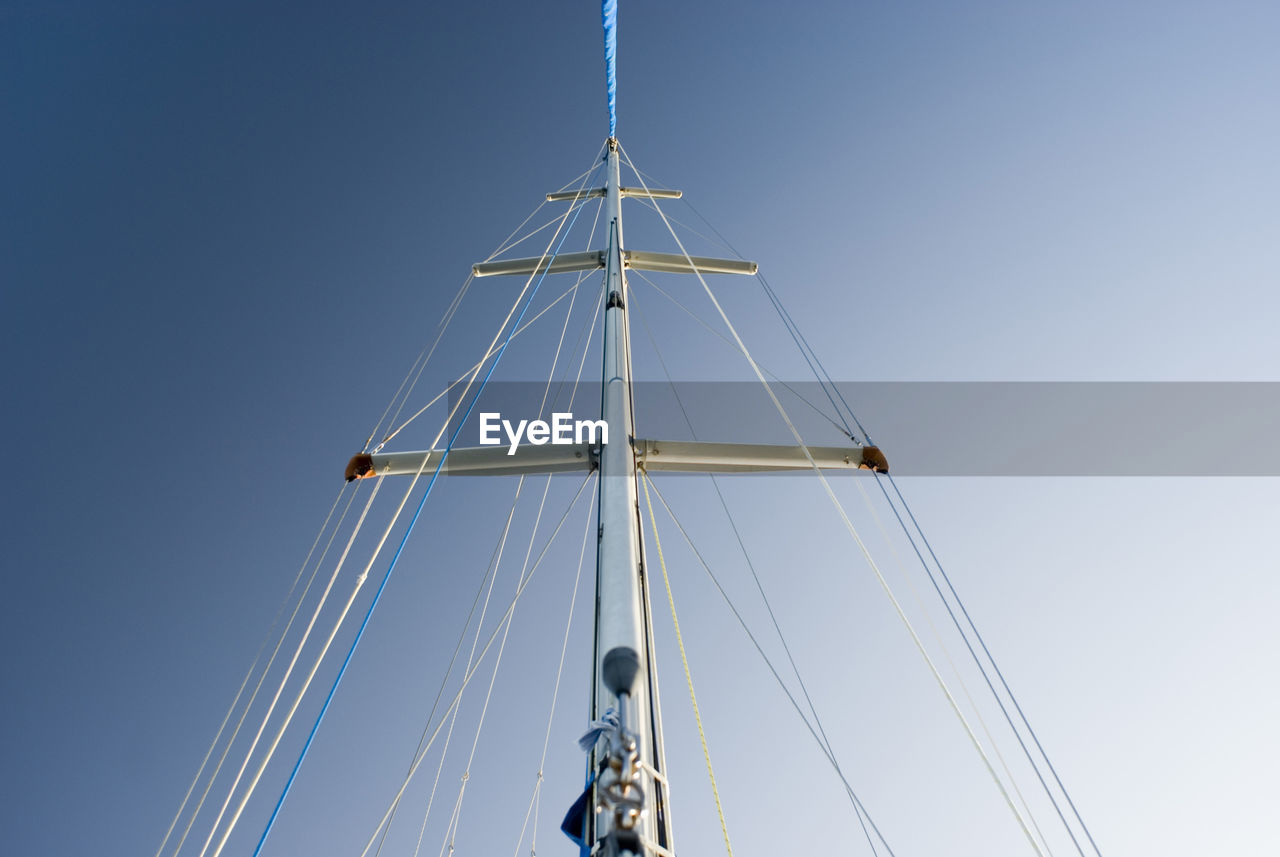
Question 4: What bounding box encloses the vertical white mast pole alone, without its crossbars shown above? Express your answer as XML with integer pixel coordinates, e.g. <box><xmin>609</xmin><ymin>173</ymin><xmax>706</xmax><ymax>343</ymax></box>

<box><xmin>586</xmin><ymin>137</ymin><xmax>671</xmax><ymax>854</ymax></box>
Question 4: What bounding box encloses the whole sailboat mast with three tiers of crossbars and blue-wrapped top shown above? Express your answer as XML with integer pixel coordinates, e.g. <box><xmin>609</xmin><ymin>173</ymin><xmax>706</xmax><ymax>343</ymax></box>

<box><xmin>346</xmin><ymin>11</ymin><xmax>855</xmax><ymax>857</ymax></box>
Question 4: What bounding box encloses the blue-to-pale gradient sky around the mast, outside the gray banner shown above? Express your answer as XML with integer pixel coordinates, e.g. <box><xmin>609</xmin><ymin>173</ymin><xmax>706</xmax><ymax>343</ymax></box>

<box><xmin>0</xmin><ymin>0</ymin><xmax>1280</xmax><ymax>857</ymax></box>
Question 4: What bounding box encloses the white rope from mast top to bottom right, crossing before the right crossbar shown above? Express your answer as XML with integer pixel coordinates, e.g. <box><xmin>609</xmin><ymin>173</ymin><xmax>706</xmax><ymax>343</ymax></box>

<box><xmin>620</xmin><ymin>146</ymin><xmax>1043</xmax><ymax>854</ymax></box>
